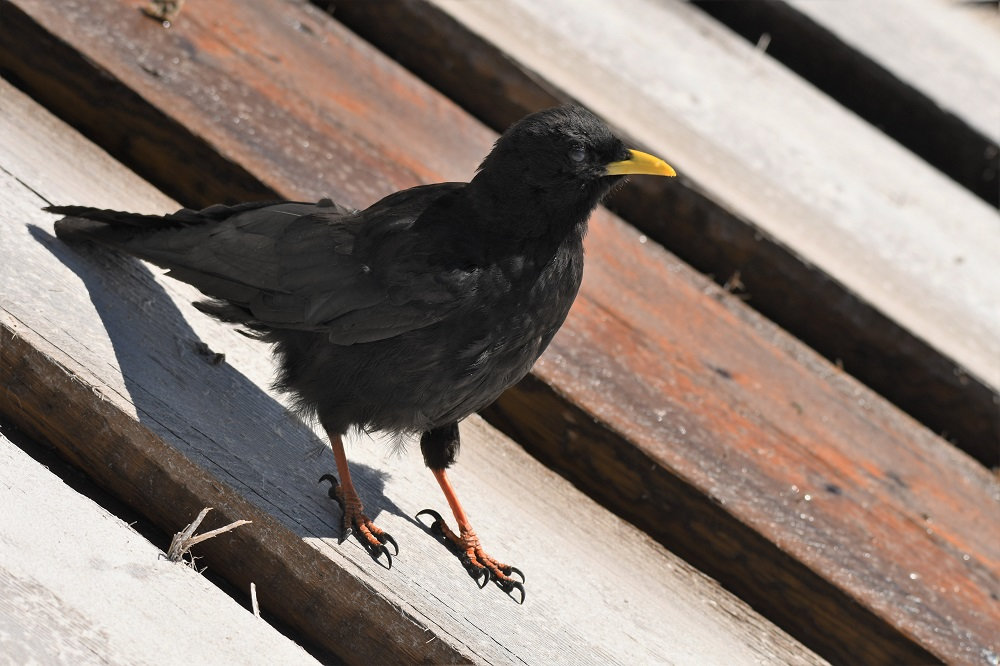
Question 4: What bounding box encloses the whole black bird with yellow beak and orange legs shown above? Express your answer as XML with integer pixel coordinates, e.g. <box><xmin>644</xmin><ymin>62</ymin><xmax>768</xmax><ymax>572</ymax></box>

<box><xmin>47</xmin><ymin>106</ymin><xmax>674</xmax><ymax>601</ymax></box>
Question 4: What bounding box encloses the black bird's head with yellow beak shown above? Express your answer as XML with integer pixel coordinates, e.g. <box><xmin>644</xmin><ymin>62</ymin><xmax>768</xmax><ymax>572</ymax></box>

<box><xmin>472</xmin><ymin>106</ymin><xmax>676</xmax><ymax>235</ymax></box>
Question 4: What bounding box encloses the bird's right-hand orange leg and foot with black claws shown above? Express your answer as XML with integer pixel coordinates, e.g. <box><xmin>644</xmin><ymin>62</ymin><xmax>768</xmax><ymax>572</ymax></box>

<box><xmin>417</xmin><ymin>469</ymin><xmax>524</xmax><ymax>603</ymax></box>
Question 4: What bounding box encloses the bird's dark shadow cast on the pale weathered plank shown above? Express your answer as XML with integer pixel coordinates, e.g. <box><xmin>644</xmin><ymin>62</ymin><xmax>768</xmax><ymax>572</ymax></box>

<box><xmin>28</xmin><ymin>225</ymin><xmax>423</xmax><ymax>537</ymax></box>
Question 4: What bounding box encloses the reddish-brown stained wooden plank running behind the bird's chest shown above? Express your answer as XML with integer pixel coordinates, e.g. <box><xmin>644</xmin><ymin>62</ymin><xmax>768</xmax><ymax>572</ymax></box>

<box><xmin>0</xmin><ymin>2</ymin><xmax>1000</xmax><ymax>662</ymax></box>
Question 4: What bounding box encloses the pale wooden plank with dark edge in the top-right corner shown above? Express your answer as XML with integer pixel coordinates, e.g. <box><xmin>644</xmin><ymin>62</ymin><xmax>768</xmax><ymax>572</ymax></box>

<box><xmin>696</xmin><ymin>0</ymin><xmax>1000</xmax><ymax>207</ymax></box>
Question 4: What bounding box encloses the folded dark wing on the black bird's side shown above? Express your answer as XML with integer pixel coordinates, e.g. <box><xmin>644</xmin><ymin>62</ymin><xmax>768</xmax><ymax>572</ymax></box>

<box><xmin>140</xmin><ymin>184</ymin><xmax>469</xmax><ymax>344</ymax></box>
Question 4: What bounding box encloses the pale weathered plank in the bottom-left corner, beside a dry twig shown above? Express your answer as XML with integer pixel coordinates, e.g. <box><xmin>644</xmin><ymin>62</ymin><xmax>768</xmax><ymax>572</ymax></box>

<box><xmin>0</xmin><ymin>434</ymin><xmax>318</xmax><ymax>664</ymax></box>
